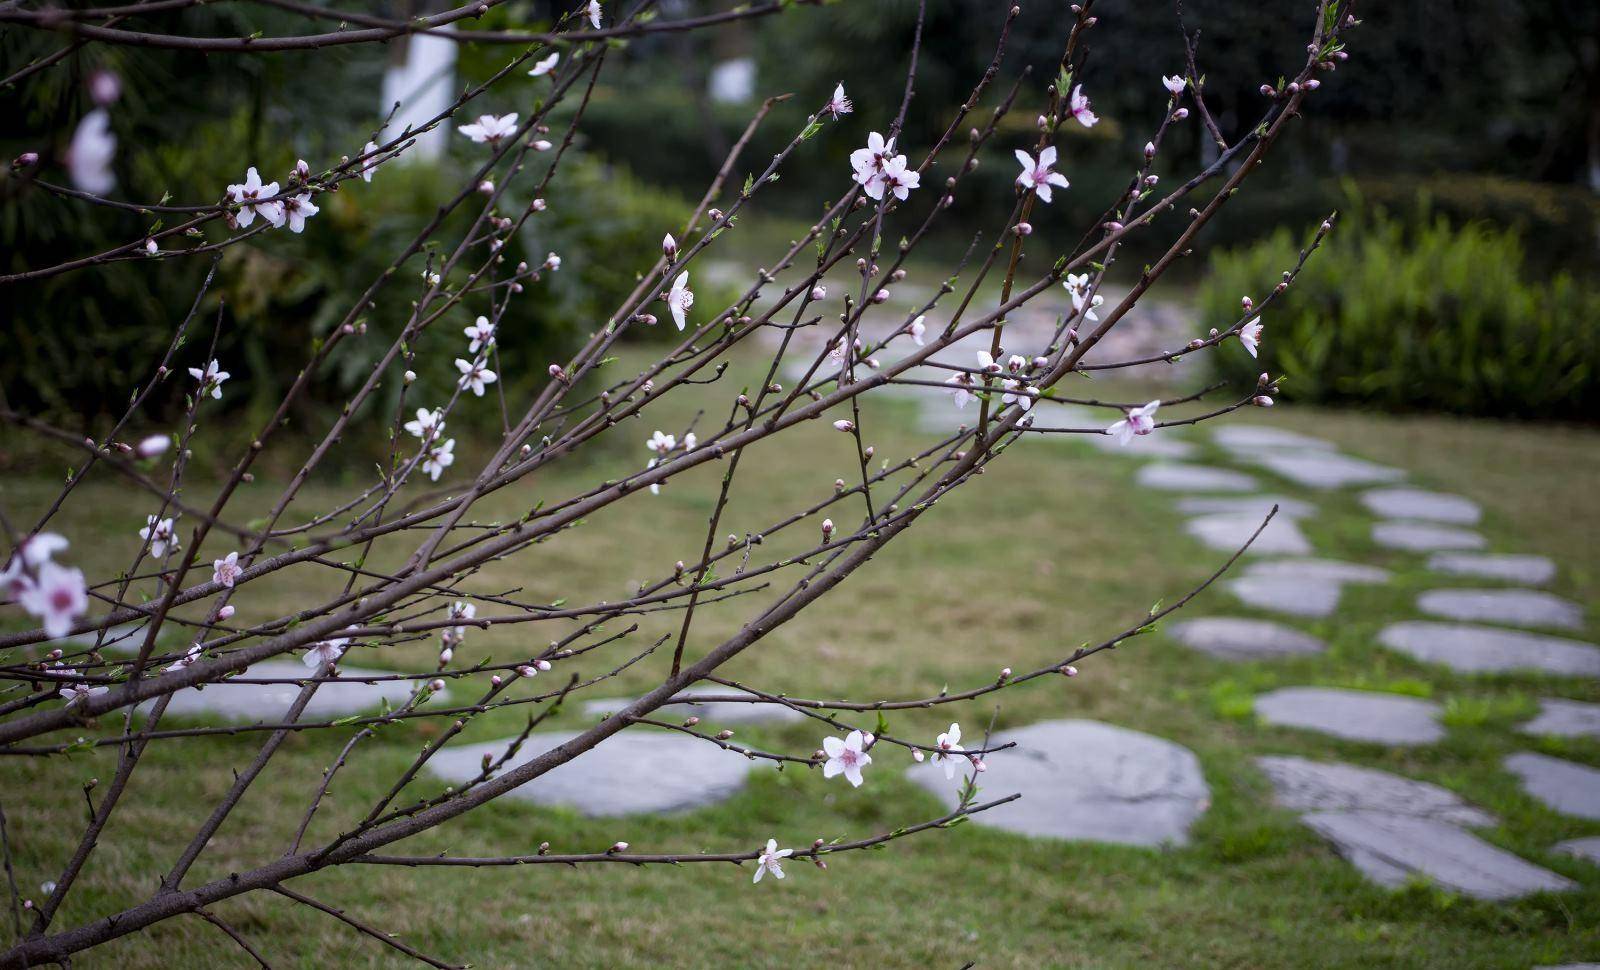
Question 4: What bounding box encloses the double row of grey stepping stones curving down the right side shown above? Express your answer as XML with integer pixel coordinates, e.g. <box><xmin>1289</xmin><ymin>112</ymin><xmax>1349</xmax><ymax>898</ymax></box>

<box><xmin>998</xmin><ymin>412</ymin><xmax>1600</xmax><ymax>900</ymax></box>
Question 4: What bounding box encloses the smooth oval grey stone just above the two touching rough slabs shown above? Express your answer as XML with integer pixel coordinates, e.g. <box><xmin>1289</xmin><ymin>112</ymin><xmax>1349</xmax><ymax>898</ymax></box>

<box><xmin>1256</xmin><ymin>687</ymin><xmax>1445</xmax><ymax>744</ymax></box>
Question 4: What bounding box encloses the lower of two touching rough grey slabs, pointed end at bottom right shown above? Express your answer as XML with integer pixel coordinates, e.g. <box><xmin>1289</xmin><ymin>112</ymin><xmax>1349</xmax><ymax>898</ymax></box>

<box><xmin>1301</xmin><ymin>812</ymin><xmax>1578</xmax><ymax>900</ymax></box>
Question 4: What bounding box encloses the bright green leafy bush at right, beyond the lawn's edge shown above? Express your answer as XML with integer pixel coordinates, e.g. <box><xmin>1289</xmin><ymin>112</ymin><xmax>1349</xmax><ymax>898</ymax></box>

<box><xmin>1200</xmin><ymin>208</ymin><xmax>1600</xmax><ymax>419</ymax></box>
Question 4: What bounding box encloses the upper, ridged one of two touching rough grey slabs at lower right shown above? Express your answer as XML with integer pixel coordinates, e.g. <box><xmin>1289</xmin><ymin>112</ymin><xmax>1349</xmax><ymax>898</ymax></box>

<box><xmin>1256</xmin><ymin>756</ymin><xmax>1496</xmax><ymax>826</ymax></box>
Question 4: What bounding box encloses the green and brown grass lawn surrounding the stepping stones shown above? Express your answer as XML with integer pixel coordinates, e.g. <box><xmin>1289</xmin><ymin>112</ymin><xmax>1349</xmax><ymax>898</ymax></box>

<box><xmin>0</xmin><ymin>345</ymin><xmax>1600</xmax><ymax>970</ymax></box>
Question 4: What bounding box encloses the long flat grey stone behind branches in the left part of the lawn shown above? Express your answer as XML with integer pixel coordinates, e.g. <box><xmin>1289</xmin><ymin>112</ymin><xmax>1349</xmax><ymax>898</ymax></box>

<box><xmin>139</xmin><ymin>659</ymin><xmax>435</xmax><ymax>723</ymax></box>
